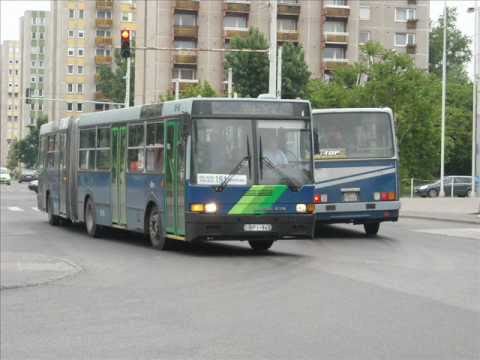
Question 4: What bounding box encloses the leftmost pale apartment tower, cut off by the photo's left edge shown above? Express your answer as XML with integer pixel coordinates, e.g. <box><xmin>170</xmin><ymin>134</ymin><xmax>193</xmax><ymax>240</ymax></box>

<box><xmin>0</xmin><ymin>40</ymin><xmax>21</xmax><ymax>166</ymax></box>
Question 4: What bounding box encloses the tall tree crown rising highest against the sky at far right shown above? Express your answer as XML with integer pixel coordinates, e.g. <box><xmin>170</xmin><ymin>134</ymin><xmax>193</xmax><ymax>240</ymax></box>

<box><xmin>429</xmin><ymin>8</ymin><xmax>472</xmax><ymax>79</ymax></box>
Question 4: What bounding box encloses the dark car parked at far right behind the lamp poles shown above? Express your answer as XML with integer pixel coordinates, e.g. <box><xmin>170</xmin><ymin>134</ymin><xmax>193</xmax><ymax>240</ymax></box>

<box><xmin>415</xmin><ymin>176</ymin><xmax>479</xmax><ymax>197</ymax></box>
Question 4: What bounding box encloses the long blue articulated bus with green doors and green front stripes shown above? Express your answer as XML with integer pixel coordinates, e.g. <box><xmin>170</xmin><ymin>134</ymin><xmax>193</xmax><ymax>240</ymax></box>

<box><xmin>38</xmin><ymin>98</ymin><xmax>315</xmax><ymax>250</ymax></box>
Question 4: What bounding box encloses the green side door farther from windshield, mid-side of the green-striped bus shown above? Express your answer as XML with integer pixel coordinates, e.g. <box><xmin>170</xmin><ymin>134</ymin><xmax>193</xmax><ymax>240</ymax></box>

<box><xmin>111</xmin><ymin>126</ymin><xmax>127</xmax><ymax>226</ymax></box>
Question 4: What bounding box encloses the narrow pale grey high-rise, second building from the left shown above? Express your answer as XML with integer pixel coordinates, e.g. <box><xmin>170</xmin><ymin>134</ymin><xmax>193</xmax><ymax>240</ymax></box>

<box><xmin>20</xmin><ymin>11</ymin><xmax>50</xmax><ymax>137</ymax></box>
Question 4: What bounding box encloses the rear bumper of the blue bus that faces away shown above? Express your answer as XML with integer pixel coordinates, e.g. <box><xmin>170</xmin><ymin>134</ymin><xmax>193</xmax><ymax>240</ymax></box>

<box><xmin>315</xmin><ymin>201</ymin><xmax>400</xmax><ymax>224</ymax></box>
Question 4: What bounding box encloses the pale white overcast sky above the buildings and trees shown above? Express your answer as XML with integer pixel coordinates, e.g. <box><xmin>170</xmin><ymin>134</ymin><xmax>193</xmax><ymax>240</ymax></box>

<box><xmin>0</xmin><ymin>0</ymin><xmax>480</xmax><ymax>74</ymax></box>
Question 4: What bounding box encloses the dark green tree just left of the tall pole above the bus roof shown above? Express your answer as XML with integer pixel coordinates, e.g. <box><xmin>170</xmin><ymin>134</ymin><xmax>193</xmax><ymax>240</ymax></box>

<box><xmin>225</xmin><ymin>28</ymin><xmax>269</xmax><ymax>97</ymax></box>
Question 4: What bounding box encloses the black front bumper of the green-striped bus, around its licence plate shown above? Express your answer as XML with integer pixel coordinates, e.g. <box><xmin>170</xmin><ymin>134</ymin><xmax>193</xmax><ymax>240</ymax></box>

<box><xmin>185</xmin><ymin>213</ymin><xmax>315</xmax><ymax>241</ymax></box>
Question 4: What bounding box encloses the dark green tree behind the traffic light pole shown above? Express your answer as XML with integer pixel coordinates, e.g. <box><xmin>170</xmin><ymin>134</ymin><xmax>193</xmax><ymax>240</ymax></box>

<box><xmin>96</xmin><ymin>45</ymin><xmax>135</xmax><ymax>105</ymax></box>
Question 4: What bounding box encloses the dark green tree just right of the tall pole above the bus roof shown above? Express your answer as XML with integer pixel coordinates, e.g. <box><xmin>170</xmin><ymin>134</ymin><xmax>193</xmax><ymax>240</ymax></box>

<box><xmin>282</xmin><ymin>43</ymin><xmax>311</xmax><ymax>99</ymax></box>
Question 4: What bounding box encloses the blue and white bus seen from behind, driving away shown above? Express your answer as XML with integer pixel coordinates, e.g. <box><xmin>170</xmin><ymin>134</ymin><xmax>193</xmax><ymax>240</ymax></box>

<box><xmin>312</xmin><ymin>108</ymin><xmax>400</xmax><ymax>235</ymax></box>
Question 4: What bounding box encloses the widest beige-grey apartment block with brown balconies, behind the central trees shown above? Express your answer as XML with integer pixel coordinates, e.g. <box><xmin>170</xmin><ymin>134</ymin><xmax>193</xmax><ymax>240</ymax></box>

<box><xmin>135</xmin><ymin>0</ymin><xmax>429</xmax><ymax>104</ymax></box>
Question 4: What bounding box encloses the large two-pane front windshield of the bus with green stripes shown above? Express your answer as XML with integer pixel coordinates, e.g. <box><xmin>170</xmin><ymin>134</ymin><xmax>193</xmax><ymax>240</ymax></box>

<box><xmin>192</xmin><ymin>119</ymin><xmax>312</xmax><ymax>186</ymax></box>
